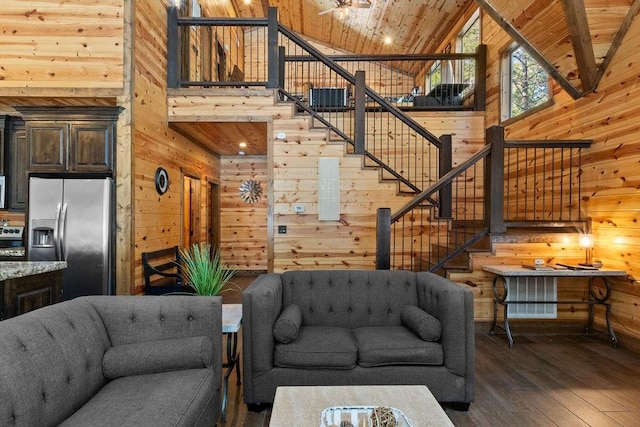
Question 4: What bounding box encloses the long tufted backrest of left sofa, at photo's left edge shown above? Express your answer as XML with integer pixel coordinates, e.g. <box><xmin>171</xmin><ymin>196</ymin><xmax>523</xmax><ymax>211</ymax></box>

<box><xmin>0</xmin><ymin>300</ymin><xmax>111</xmax><ymax>426</ymax></box>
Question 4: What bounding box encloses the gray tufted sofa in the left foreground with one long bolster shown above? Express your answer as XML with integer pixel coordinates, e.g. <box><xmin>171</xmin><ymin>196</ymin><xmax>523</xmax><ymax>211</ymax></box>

<box><xmin>0</xmin><ymin>296</ymin><xmax>222</xmax><ymax>427</ymax></box>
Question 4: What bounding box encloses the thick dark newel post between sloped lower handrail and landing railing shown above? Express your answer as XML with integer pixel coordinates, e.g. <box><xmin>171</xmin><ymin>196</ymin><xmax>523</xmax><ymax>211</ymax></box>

<box><xmin>484</xmin><ymin>126</ymin><xmax>506</xmax><ymax>233</ymax></box>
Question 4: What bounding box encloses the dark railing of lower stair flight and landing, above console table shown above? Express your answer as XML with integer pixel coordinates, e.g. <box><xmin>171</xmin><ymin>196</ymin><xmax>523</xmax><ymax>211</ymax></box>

<box><xmin>376</xmin><ymin>126</ymin><xmax>592</xmax><ymax>272</ymax></box>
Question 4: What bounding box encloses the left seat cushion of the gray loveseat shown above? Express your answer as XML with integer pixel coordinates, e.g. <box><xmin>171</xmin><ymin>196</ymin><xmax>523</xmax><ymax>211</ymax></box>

<box><xmin>273</xmin><ymin>326</ymin><xmax>358</xmax><ymax>369</ymax></box>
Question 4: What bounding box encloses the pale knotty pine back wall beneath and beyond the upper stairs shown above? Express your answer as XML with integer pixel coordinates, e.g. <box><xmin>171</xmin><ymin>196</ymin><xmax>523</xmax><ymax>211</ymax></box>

<box><xmin>273</xmin><ymin>112</ymin><xmax>484</xmax><ymax>271</ymax></box>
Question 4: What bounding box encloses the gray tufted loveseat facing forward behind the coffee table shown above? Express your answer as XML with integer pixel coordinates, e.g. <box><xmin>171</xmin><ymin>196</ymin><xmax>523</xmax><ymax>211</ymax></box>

<box><xmin>242</xmin><ymin>270</ymin><xmax>475</xmax><ymax>411</ymax></box>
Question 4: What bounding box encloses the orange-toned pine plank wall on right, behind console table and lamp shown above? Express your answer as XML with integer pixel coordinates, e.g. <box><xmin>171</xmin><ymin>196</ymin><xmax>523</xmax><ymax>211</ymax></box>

<box><xmin>452</xmin><ymin>5</ymin><xmax>640</xmax><ymax>345</ymax></box>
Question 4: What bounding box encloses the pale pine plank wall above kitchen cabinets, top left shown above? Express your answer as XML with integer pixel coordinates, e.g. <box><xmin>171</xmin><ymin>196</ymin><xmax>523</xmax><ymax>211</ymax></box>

<box><xmin>0</xmin><ymin>0</ymin><xmax>124</xmax><ymax>96</ymax></box>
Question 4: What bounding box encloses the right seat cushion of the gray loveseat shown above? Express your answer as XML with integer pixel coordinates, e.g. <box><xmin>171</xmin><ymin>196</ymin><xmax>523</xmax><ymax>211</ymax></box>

<box><xmin>353</xmin><ymin>326</ymin><xmax>444</xmax><ymax>367</ymax></box>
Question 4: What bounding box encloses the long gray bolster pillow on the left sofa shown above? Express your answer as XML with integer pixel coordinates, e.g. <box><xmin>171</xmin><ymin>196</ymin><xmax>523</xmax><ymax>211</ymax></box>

<box><xmin>102</xmin><ymin>337</ymin><xmax>213</xmax><ymax>379</ymax></box>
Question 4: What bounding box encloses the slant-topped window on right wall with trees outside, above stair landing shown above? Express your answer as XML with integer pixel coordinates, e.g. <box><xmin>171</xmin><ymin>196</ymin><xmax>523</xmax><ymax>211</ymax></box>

<box><xmin>502</xmin><ymin>45</ymin><xmax>551</xmax><ymax>120</ymax></box>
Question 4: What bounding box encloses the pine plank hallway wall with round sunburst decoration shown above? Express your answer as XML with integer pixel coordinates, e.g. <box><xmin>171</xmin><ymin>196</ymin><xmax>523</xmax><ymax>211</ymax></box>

<box><xmin>220</xmin><ymin>156</ymin><xmax>269</xmax><ymax>271</ymax></box>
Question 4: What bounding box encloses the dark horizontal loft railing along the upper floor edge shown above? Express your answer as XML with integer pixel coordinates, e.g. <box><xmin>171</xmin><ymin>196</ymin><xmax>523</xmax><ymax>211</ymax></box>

<box><xmin>168</xmin><ymin>7</ymin><xmax>486</xmax><ymax>110</ymax></box>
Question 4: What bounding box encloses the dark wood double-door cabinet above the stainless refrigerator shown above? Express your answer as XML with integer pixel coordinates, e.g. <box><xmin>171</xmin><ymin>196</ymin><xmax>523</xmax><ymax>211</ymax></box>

<box><xmin>17</xmin><ymin>107</ymin><xmax>121</xmax><ymax>173</ymax></box>
